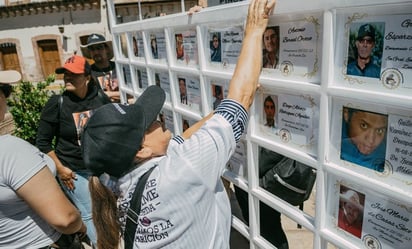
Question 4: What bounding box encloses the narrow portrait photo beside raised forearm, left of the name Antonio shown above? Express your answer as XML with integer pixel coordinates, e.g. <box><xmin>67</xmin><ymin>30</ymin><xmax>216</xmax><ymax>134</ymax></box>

<box><xmin>262</xmin><ymin>26</ymin><xmax>279</xmax><ymax>68</ymax></box>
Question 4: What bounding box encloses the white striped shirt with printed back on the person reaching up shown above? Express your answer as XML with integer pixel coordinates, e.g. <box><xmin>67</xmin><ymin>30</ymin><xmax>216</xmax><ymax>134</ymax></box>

<box><xmin>117</xmin><ymin>99</ymin><xmax>248</xmax><ymax>249</ymax></box>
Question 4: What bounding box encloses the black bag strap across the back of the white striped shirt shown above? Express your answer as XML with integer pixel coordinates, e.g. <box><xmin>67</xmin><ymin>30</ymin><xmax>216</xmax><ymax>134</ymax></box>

<box><xmin>124</xmin><ymin>167</ymin><xmax>155</xmax><ymax>249</ymax></box>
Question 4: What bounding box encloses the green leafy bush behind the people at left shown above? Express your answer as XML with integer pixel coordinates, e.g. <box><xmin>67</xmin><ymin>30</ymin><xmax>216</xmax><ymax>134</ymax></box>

<box><xmin>8</xmin><ymin>75</ymin><xmax>55</xmax><ymax>144</ymax></box>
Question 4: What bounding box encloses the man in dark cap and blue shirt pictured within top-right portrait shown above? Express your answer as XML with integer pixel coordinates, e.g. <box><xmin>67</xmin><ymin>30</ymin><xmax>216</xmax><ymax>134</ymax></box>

<box><xmin>346</xmin><ymin>23</ymin><xmax>381</xmax><ymax>78</ymax></box>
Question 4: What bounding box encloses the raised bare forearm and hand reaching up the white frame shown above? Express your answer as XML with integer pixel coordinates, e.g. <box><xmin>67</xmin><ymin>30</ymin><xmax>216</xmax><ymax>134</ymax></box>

<box><xmin>227</xmin><ymin>0</ymin><xmax>276</xmax><ymax>111</ymax></box>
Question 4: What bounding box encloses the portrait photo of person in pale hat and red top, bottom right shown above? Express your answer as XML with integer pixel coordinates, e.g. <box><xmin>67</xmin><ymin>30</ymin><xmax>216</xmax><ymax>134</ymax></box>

<box><xmin>338</xmin><ymin>186</ymin><xmax>365</xmax><ymax>238</ymax></box>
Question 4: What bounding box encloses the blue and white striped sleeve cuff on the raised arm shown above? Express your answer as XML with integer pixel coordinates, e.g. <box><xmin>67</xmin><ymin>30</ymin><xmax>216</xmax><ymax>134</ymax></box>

<box><xmin>215</xmin><ymin>99</ymin><xmax>248</xmax><ymax>143</ymax></box>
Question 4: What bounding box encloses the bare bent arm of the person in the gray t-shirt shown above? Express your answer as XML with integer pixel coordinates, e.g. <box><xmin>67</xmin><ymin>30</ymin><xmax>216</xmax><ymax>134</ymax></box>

<box><xmin>17</xmin><ymin>166</ymin><xmax>86</xmax><ymax>234</ymax></box>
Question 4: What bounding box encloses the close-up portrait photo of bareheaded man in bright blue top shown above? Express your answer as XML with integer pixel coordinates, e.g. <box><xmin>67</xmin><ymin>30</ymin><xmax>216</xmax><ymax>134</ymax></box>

<box><xmin>340</xmin><ymin>107</ymin><xmax>388</xmax><ymax>172</ymax></box>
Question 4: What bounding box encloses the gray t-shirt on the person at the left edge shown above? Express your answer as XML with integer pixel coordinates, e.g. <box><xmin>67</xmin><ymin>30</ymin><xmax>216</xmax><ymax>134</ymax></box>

<box><xmin>0</xmin><ymin>135</ymin><xmax>61</xmax><ymax>249</ymax></box>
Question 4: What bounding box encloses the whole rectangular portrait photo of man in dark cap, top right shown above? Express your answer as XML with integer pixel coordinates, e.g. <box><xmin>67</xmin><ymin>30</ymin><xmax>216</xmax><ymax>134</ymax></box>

<box><xmin>346</xmin><ymin>22</ymin><xmax>385</xmax><ymax>79</ymax></box>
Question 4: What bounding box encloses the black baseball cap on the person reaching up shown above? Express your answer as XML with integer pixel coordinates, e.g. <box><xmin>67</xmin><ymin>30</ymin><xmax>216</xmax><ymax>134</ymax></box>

<box><xmin>81</xmin><ymin>86</ymin><xmax>165</xmax><ymax>177</ymax></box>
